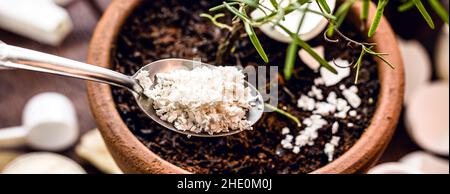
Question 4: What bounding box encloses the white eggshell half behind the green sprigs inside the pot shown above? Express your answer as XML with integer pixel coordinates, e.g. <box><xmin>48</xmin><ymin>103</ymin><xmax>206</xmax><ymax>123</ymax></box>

<box><xmin>250</xmin><ymin>0</ymin><xmax>336</xmax><ymax>43</ymax></box>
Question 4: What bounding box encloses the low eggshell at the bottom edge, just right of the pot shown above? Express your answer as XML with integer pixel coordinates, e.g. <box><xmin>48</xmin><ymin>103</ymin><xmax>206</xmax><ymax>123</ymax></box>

<box><xmin>367</xmin><ymin>162</ymin><xmax>423</xmax><ymax>174</ymax></box>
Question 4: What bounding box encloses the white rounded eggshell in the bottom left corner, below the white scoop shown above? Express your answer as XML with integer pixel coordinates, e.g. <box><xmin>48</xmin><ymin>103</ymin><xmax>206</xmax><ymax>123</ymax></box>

<box><xmin>2</xmin><ymin>152</ymin><xmax>86</xmax><ymax>174</ymax></box>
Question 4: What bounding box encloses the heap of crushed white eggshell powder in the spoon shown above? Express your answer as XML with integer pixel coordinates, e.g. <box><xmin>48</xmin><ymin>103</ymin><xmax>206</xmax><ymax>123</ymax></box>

<box><xmin>137</xmin><ymin>67</ymin><xmax>256</xmax><ymax>134</ymax></box>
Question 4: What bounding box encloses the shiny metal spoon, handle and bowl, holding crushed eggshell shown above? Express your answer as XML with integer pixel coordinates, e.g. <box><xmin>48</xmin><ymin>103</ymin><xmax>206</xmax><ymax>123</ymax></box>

<box><xmin>0</xmin><ymin>41</ymin><xmax>264</xmax><ymax>137</ymax></box>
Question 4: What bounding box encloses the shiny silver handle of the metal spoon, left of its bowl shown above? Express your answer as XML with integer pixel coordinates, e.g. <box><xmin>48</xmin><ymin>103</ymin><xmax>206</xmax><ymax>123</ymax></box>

<box><xmin>0</xmin><ymin>41</ymin><xmax>140</xmax><ymax>91</ymax></box>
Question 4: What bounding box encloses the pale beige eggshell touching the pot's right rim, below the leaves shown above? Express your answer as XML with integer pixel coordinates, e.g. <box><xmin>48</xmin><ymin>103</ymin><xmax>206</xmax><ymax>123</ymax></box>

<box><xmin>399</xmin><ymin>40</ymin><xmax>431</xmax><ymax>104</ymax></box>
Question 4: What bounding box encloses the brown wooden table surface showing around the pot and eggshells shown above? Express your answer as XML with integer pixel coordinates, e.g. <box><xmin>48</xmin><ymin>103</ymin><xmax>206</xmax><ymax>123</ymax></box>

<box><xmin>0</xmin><ymin>0</ymin><xmax>446</xmax><ymax>173</ymax></box>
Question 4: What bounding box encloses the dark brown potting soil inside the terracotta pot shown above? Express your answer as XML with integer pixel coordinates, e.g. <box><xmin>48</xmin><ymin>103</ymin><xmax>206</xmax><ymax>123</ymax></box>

<box><xmin>111</xmin><ymin>0</ymin><xmax>380</xmax><ymax>173</ymax></box>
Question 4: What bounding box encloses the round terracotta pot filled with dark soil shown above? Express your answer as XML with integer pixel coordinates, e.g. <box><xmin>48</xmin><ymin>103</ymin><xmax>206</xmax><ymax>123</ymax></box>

<box><xmin>87</xmin><ymin>0</ymin><xmax>404</xmax><ymax>173</ymax></box>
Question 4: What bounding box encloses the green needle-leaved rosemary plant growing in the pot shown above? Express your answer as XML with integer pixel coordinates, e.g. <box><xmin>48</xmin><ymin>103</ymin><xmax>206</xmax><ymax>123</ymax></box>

<box><xmin>202</xmin><ymin>0</ymin><xmax>448</xmax><ymax>83</ymax></box>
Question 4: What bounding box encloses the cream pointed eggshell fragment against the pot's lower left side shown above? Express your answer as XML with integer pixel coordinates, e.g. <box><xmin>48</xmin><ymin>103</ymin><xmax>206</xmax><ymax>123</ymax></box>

<box><xmin>75</xmin><ymin>129</ymin><xmax>122</xmax><ymax>174</ymax></box>
